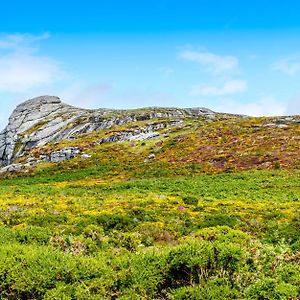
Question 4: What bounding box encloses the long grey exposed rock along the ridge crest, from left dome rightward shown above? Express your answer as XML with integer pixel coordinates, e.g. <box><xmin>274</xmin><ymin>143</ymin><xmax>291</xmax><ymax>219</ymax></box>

<box><xmin>0</xmin><ymin>96</ymin><xmax>236</xmax><ymax>166</ymax></box>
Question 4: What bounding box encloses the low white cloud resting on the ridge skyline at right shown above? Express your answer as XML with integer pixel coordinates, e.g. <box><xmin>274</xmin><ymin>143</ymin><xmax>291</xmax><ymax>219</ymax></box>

<box><xmin>215</xmin><ymin>96</ymin><xmax>287</xmax><ymax>117</ymax></box>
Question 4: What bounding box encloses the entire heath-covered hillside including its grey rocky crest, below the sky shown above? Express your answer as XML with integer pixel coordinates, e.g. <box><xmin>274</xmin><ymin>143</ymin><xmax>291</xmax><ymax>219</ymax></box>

<box><xmin>0</xmin><ymin>96</ymin><xmax>300</xmax><ymax>300</ymax></box>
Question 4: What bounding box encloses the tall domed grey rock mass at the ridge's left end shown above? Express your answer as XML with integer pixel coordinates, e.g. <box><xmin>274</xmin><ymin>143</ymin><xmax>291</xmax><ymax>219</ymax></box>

<box><xmin>0</xmin><ymin>96</ymin><xmax>82</xmax><ymax>165</ymax></box>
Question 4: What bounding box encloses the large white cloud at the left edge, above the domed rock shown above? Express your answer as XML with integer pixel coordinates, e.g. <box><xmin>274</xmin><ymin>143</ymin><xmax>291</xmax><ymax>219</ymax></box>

<box><xmin>0</xmin><ymin>34</ymin><xmax>65</xmax><ymax>93</ymax></box>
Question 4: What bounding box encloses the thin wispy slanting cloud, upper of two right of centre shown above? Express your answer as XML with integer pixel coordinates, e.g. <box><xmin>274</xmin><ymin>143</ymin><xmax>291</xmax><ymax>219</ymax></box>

<box><xmin>179</xmin><ymin>50</ymin><xmax>239</xmax><ymax>74</ymax></box>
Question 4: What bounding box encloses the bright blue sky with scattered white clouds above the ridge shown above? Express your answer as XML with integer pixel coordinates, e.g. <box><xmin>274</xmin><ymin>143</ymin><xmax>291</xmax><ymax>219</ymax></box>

<box><xmin>0</xmin><ymin>0</ymin><xmax>300</xmax><ymax>128</ymax></box>
